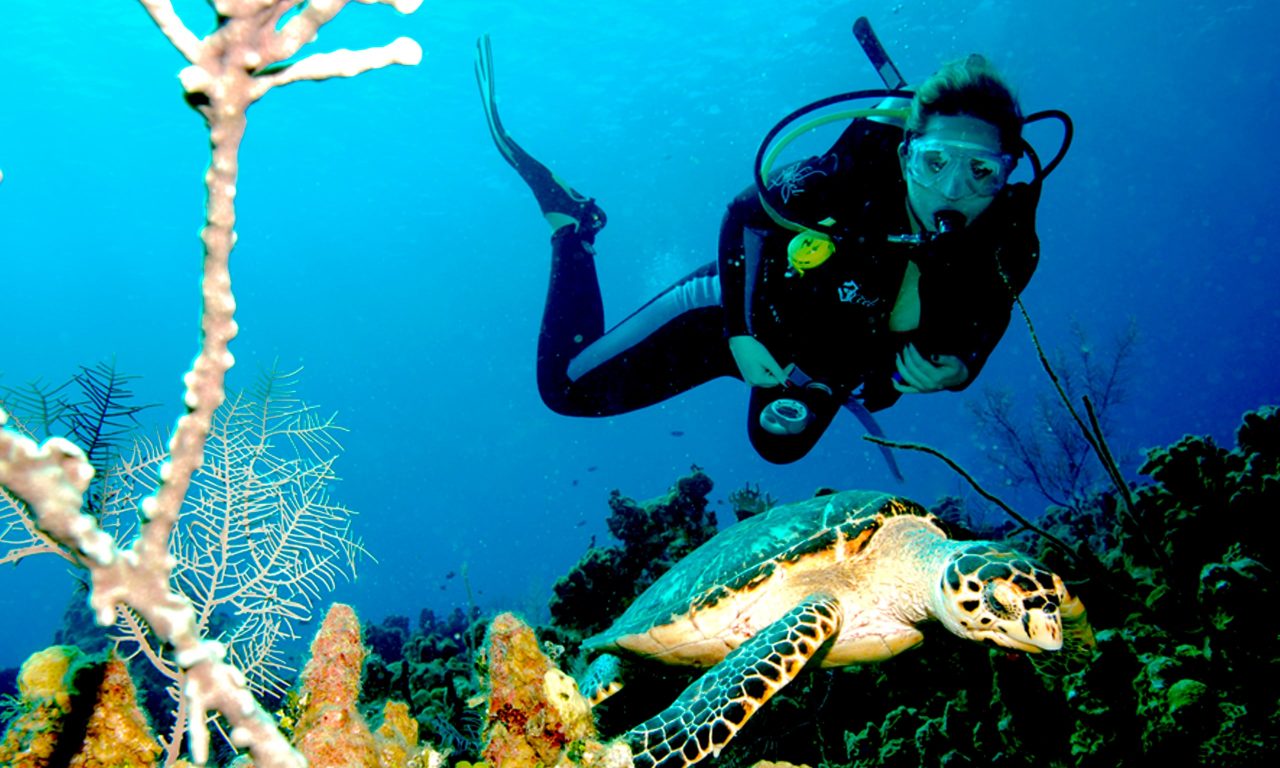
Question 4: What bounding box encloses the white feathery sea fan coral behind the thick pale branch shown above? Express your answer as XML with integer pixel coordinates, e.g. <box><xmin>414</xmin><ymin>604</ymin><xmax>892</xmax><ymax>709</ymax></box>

<box><xmin>115</xmin><ymin>371</ymin><xmax>367</xmax><ymax>750</ymax></box>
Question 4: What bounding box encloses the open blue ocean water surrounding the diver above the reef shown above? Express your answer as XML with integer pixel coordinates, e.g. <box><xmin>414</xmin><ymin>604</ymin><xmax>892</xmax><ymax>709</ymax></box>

<box><xmin>0</xmin><ymin>0</ymin><xmax>1280</xmax><ymax>667</ymax></box>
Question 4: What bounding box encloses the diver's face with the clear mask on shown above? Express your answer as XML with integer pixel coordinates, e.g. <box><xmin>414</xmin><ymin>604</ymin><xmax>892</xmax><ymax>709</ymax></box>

<box><xmin>899</xmin><ymin>115</ymin><xmax>1012</xmax><ymax>230</ymax></box>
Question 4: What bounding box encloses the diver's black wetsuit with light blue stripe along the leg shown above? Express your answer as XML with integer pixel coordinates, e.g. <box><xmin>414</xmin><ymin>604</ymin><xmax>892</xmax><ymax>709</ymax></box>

<box><xmin>538</xmin><ymin>120</ymin><xmax>1039</xmax><ymax>463</ymax></box>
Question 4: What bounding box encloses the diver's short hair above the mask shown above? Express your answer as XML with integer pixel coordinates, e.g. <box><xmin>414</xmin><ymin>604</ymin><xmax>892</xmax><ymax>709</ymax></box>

<box><xmin>906</xmin><ymin>54</ymin><xmax>1023</xmax><ymax>157</ymax></box>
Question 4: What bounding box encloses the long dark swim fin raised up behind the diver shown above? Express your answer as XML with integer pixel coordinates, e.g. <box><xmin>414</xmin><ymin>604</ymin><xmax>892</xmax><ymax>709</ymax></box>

<box><xmin>476</xmin><ymin>35</ymin><xmax>608</xmax><ymax>241</ymax></box>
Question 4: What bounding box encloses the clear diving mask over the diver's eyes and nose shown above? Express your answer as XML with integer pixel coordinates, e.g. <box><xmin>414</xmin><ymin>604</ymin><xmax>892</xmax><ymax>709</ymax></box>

<box><xmin>906</xmin><ymin>138</ymin><xmax>1014</xmax><ymax>198</ymax></box>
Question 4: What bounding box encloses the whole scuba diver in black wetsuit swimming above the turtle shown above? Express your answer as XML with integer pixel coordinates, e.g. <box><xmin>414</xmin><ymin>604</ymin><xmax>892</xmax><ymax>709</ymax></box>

<box><xmin>476</xmin><ymin>19</ymin><xmax>1070</xmax><ymax>468</ymax></box>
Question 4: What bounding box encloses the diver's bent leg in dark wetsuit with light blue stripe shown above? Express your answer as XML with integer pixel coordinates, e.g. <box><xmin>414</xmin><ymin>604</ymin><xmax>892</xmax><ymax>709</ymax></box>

<box><xmin>538</xmin><ymin>262</ymin><xmax>737</xmax><ymax>416</ymax></box>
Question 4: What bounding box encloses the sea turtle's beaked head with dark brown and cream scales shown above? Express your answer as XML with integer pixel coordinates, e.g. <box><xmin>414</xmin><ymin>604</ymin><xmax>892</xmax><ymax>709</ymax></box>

<box><xmin>936</xmin><ymin>541</ymin><xmax>1078</xmax><ymax>653</ymax></box>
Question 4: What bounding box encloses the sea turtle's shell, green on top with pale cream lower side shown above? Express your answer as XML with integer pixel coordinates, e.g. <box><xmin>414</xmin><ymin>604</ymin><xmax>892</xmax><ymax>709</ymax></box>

<box><xmin>582</xmin><ymin>490</ymin><xmax>945</xmax><ymax>666</ymax></box>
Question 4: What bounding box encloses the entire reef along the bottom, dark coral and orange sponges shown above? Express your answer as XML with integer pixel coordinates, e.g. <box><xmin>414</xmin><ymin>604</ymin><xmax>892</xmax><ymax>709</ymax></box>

<box><xmin>0</xmin><ymin>407</ymin><xmax>1280</xmax><ymax>768</ymax></box>
